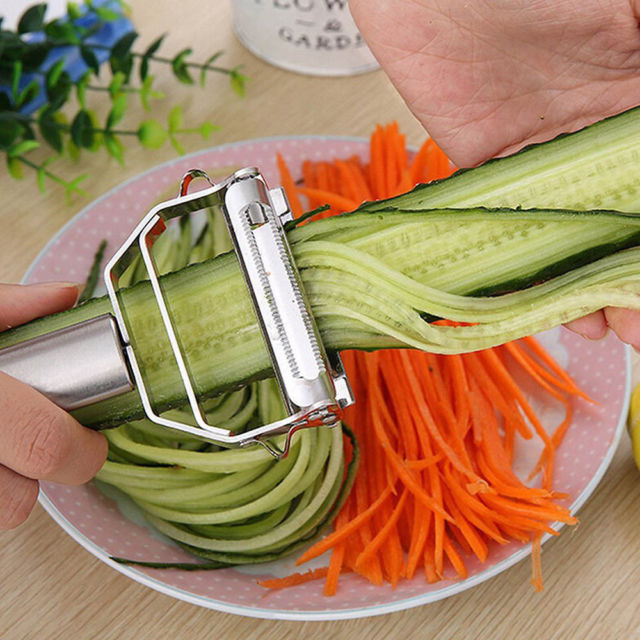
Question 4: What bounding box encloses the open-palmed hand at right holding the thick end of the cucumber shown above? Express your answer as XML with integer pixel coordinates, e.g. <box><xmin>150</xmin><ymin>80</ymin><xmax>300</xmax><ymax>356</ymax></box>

<box><xmin>350</xmin><ymin>0</ymin><xmax>640</xmax><ymax>349</ymax></box>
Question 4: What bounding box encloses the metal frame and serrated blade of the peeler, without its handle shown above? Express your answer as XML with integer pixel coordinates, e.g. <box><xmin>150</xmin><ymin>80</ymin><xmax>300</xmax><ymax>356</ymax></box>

<box><xmin>104</xmin><ymin>168</ymin><xmax>354</xmax><ymax>458</ymax></box>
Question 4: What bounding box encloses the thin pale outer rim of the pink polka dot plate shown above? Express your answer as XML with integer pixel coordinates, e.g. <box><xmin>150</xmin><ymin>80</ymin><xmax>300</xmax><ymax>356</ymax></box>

<box><xmin>28</xmin><ymin>134</ymin><xmax>631</xmax><ymax>622</ymax></box>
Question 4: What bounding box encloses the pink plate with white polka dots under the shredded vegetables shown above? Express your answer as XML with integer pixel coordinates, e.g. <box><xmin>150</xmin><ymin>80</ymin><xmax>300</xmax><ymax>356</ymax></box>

<box><xmin>25</xmin><ymin>137</ymin><xmax>630</xmax><ymax>620</ymax></box>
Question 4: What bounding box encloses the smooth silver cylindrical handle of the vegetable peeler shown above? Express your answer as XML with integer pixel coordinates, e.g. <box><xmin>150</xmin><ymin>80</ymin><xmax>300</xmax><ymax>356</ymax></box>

<box><xmin>0</xmin><ymin>314</ymin><xmax>133</xmax><ymax>411</ymax></box>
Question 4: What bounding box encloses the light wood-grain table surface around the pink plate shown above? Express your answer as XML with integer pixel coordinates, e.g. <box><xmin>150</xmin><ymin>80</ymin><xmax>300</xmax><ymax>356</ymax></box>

<box><xmin>0</xmin><ymin>0</ymin><xmax>640</xmax><ymax>640</ymax></box>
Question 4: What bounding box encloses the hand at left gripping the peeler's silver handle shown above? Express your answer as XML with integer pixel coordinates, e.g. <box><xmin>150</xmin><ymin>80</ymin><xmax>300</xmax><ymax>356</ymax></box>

<box><xmin>0</xmin><ymin>283</ymin><xmax>107</xmax><ymax>530</ymax></box>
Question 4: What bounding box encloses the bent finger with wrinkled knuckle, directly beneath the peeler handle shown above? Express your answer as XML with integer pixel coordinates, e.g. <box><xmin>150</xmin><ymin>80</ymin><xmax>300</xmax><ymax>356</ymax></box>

<box><xmin>0</xmin><ymin>373</ymin><xmax>107</xmax><ymax>484</ymax></box>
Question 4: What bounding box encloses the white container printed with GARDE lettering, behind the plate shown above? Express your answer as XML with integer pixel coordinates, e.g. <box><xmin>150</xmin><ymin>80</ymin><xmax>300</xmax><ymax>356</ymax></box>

<box><xmin>231</xmin><ymin>0</ymin><xmax>378</xmax><ymax>76</ymax></box>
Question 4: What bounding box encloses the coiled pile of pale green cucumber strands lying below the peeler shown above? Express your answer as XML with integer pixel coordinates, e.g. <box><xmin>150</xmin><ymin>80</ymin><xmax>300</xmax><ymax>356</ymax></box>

<box><xmin>97</xmin><ymin>422</ymin><xmax>359</xmax><ymax>570</ymax></box>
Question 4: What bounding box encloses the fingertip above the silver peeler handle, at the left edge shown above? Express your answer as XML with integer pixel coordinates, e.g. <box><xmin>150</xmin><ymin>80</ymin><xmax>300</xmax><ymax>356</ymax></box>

<box><xmin>0</xmin><ymin>282</ymin><xmax>80</xmax><ymax>331</ymax></box>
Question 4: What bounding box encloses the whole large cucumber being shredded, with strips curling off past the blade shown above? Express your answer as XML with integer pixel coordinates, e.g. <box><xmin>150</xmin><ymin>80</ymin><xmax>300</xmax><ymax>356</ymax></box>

<box><xmin>0</xmin><ymin>109</ymin><xmax>640</xmax><ymax>426</ymax></box>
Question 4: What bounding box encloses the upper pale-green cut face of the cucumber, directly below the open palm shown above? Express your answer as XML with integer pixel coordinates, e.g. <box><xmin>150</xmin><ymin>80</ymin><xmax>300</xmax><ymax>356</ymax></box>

<box><xmin>363</xmin><ymin>107</ymin><xmax>640</xmax><ymax>211</ymax></box>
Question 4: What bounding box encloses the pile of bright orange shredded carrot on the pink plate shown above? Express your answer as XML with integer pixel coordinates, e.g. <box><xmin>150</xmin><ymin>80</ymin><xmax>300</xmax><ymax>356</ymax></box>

<box><xmin>261</xmin><ymin>123</ymin><xmax>592</xmax><ymax>595</ymax></box>
